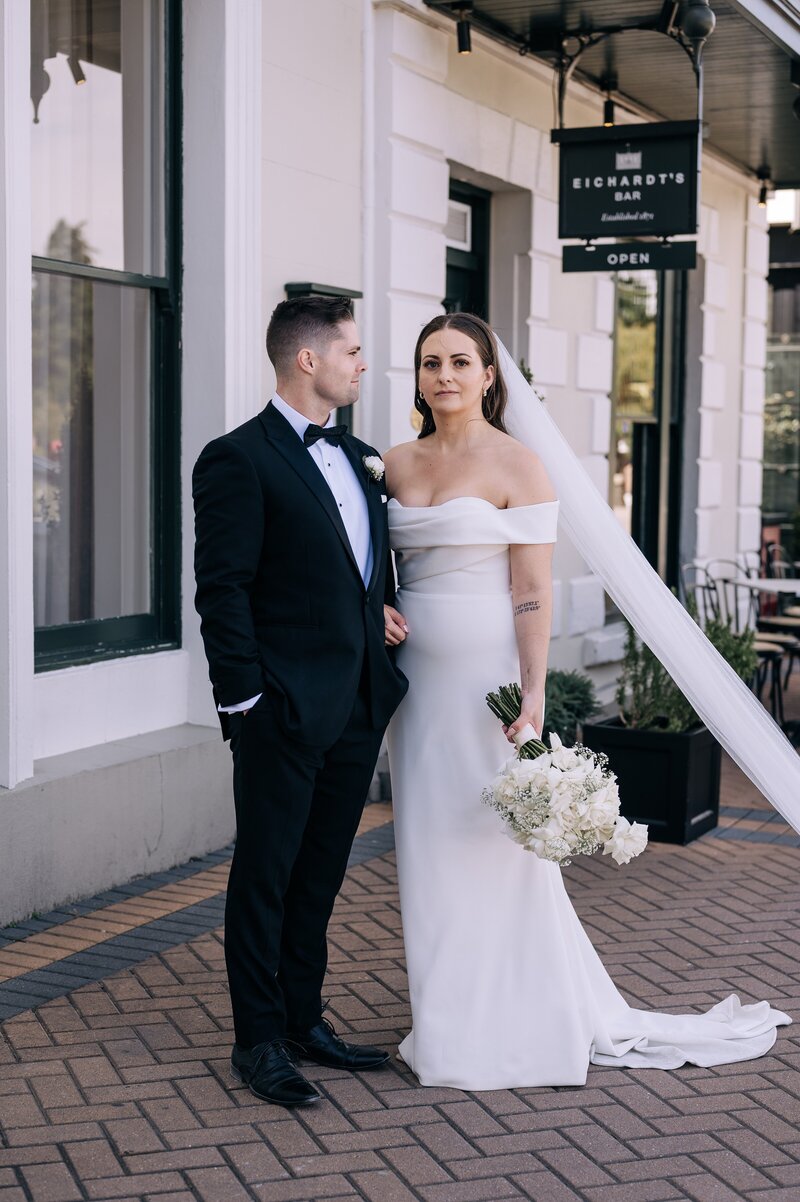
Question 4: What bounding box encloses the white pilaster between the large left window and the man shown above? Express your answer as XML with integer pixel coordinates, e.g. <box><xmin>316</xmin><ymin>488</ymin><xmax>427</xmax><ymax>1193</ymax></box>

<box><xmin>181</xmin><ymin>0</ymin><xmax>264</xmax><ymax>722</ymax></box>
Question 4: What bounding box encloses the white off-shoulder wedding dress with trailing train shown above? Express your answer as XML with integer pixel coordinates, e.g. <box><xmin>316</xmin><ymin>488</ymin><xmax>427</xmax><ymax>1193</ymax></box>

<box><xmin>389</xmin><ymin>496</ymin><xmax>790</xmax><ymax>1090</ymax></box>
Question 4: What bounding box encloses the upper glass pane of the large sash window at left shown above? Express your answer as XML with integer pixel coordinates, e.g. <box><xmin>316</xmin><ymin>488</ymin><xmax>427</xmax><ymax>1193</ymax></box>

<box><xmin>31</xmin><ymin>0</ymin><xmax>165</xmax><ymax>275</ymax></box>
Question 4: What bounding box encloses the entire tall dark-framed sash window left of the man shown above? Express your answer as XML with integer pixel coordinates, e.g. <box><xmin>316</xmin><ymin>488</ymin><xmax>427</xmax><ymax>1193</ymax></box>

<box><xmin>31</xmin><ymin>0</ymin><xmax>180</xmax><ymax>670</ymax></box>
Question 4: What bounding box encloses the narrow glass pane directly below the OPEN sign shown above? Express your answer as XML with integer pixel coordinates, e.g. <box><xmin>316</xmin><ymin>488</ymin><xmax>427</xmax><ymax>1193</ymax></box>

<box><xmin>610</xmin><ymin>272</ymin><xmax>658</xmax><ymax>534</ymax></box>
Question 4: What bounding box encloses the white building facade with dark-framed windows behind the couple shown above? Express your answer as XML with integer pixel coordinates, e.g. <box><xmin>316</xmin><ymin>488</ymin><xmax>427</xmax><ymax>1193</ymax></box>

<box><xmin>0</xmin><ymin>0</ymin><xmax>800</xmax><ymax>921</ymax></box>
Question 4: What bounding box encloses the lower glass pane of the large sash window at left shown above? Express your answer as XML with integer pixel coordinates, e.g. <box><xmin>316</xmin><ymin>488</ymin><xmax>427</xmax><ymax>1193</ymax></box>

<box><xmin>34</xmin><ymin>273</ymin><xmax>151</xmax><ymax>626</ymax></box>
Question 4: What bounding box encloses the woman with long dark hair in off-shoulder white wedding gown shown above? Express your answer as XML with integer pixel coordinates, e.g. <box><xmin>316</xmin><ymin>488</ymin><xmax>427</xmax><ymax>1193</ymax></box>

<box><xmin>386</xmin><ymin>314</ymin><xmax>790</xmax><ymax>1090</ymax></box>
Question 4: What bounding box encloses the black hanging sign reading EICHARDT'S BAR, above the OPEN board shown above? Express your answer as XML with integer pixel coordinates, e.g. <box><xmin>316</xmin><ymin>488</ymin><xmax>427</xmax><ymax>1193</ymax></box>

<box><xmin>550</xmin><ymin>121</ymin><xmax>698</xmax><ymax>238</ymax></box>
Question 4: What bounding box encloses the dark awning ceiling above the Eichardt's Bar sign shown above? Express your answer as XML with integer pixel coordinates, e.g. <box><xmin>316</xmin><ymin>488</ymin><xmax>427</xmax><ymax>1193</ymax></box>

<box><xmin>425</xmin><ymin>0</ymin><xmax>800</xmax><ymax>188</ymax></box>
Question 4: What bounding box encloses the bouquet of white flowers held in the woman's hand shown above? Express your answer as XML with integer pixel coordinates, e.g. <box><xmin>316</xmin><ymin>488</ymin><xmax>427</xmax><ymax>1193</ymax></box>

<box><xmin>482</xmin><ymin>684</ymin><xmax>647</xmax><ymax>865</ymax></box>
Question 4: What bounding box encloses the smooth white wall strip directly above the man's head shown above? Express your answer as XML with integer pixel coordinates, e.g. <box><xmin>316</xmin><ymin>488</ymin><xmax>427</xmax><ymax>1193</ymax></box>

<box><xmin>261</xmin><ymin>0</ymin><xmax>369</xmax><ymax>401</ymax></box>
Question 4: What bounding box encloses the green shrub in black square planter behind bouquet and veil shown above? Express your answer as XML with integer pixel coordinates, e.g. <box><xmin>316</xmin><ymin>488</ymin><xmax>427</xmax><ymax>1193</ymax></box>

<box><xmin>583</xmin><ymin>613</ymin><xmax>758</xmax><ymax>844</ymax></box>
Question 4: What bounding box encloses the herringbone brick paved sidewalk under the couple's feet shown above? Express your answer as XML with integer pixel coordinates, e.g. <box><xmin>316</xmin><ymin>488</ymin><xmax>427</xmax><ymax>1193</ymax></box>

<box><xmin>0</xmin><ymin>768</ymin><xmax>800</xmax><ymax>1202</ymax></box>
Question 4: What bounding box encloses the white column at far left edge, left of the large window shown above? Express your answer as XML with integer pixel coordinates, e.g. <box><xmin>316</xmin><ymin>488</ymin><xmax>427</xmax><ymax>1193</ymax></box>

<box><xmin>0</xmin><ymin>0</ymin><xmax>35</xmax><ymax>789</ymax></box>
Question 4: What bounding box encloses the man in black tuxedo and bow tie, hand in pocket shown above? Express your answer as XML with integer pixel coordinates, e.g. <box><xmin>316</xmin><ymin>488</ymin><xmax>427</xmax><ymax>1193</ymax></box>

<box><xmin>193</xmin><ymin>297</ymin><xmax>406</xmax><ymax>1106</ymax></box>
